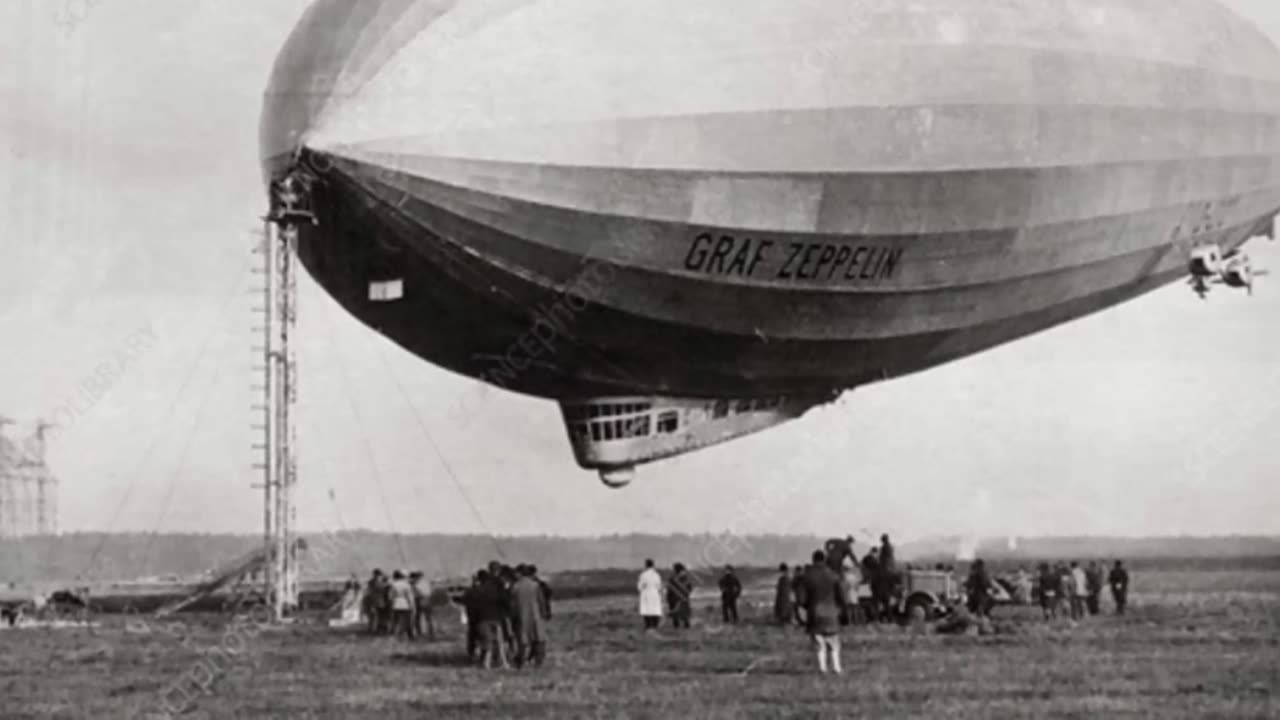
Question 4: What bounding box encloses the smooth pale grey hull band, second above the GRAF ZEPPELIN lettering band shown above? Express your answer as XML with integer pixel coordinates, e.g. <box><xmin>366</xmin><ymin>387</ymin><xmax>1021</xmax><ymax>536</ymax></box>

<box><xmin>330</xmin><ymin>104</ymin><xmax>1280</xmax><ymax>176</ymax></box>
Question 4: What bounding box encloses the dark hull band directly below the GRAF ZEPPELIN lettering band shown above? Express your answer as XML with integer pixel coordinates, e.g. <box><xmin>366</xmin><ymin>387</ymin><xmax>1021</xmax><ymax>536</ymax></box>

<box><xmin>332</xmin><ymin>151</ymin><xmax>1274</xmax><ymax>340</ymax></box>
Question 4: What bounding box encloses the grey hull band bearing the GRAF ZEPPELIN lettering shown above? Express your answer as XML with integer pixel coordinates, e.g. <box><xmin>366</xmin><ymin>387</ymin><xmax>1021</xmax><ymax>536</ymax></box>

<box><xmin>332</xmin><ymin>150</ymin><xmax>1280</xmax><ymax>288</ymax></box>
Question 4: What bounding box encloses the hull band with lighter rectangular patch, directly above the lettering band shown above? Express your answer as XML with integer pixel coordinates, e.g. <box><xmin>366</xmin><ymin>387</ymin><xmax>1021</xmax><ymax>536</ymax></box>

<box><xmin>333</xmin><ymin>144</ymin><xmax>1280</xmax><ymax>239</ymax></box>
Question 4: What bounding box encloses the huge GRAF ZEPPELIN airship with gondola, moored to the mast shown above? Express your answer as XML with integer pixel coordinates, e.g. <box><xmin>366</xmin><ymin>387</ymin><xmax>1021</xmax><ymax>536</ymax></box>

<box><xmin>260</xmin><ymin>0</ymin><xmax>1280</xmax><ymax>486</ymax></box>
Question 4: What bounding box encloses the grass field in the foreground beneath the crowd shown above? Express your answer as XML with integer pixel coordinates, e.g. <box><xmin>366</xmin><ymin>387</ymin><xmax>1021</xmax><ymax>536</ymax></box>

<box><xmin>0</xmin><ymin>564</ymin><xmax>1280</xmax><ymax>720</ymax></box>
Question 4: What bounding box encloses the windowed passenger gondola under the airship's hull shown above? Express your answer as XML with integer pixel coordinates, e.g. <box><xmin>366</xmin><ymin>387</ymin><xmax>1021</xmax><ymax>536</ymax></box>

<box><xmin>561</xmin><ymin>391</ymin><xmax>840</xmax><ymax>488</ymax></box>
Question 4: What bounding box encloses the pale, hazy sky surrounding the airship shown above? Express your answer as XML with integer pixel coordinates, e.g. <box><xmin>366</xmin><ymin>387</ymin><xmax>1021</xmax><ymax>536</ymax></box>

<box><xmin>0</xmin><ymin>0</ymin><xmax>1280</xmax><ymax>538</ymax></box>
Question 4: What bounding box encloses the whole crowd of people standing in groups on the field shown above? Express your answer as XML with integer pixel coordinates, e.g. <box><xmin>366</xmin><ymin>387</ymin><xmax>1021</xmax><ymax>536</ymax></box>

<box><xmin>348</xmin><ymin>534</ymin><xmax>1129</xmax><ymax>674</ymax></box>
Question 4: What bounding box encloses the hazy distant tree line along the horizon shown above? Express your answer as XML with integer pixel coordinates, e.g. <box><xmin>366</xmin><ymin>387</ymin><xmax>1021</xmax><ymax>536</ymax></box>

<box><xmin>0</xmin><ymin>532</ymin><xmax>1280</xmax><ymax>583</ymax></box>
